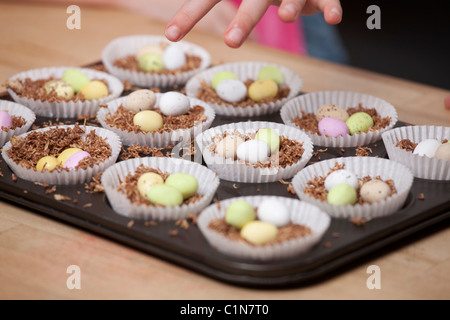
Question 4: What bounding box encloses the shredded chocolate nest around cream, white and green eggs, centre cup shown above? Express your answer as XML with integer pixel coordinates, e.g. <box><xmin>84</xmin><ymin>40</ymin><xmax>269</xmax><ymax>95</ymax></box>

<box><xmin>208</xmin><ymin>131</ymin><xmax>305</xmax><ymax>168</ymax></box>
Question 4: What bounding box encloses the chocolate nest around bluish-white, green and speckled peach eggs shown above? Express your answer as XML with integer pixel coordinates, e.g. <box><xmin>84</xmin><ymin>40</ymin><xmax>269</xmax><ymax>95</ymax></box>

<box><xmin>303</xmin><ymin>162</ymin><xmax>397</xmax><ymax>205</ymax></box>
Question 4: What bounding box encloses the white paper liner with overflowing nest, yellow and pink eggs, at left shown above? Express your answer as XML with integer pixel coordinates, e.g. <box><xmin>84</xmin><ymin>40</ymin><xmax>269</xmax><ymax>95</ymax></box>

<box><xmin>2</xmin><ymin>125</ymin><xmax>122</xmax><ymax>185</ymax></box>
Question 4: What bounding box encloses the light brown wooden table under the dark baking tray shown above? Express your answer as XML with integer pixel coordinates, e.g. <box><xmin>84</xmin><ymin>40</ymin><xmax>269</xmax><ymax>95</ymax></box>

<box><xmin>0</xmin><ymin>2</ymin><xmax>450</xmax><ymax>300</ymax></box>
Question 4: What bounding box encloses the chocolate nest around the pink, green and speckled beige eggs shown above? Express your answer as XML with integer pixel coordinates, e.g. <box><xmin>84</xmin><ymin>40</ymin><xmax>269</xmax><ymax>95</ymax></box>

<box><xmin>294</xmin><ymin>103</ymin><xmax>392</xmax><ymax>135</ymax></box>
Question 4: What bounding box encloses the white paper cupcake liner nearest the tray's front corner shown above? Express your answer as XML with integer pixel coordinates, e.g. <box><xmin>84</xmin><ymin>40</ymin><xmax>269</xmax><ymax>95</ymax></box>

<box><xmin>197</xmin><ymin>196</ymin><xmax>331</xmax><ymax>261</ymax></box>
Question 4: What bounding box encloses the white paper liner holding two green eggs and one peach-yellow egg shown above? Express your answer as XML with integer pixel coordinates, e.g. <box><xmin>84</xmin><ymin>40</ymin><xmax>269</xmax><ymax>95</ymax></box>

<box><xmin>102</xmin><ymin>157</ymin><xmax>219</xmax><ymax>221</ymax></box>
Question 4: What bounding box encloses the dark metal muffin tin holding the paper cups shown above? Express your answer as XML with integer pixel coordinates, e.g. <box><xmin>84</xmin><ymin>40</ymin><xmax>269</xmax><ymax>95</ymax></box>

<box><xmin>0</xmin><ymin>63</ymin><xmax>450</xmax><ymax>288</ymax></box>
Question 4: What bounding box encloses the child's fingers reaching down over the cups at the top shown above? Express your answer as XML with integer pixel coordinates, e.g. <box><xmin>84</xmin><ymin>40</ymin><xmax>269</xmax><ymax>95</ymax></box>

<box><xmin>165</xmin><ymin>0</ymin><xmax>342</xmax><ymax>48</ymax></box>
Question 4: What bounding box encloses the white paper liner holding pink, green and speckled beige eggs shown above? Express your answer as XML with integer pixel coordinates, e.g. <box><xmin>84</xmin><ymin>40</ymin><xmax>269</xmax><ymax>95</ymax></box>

<box><xmin>280</xmin><ymin>91</ymin><xmax>398</xmax><ymax>148</ymax></box>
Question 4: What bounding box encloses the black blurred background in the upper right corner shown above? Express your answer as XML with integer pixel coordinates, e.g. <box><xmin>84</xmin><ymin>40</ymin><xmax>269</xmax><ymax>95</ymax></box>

<box><xmin>338</xmin><ymin>0</ymin><xmax>450</xmax><ymax>89</ymax></box>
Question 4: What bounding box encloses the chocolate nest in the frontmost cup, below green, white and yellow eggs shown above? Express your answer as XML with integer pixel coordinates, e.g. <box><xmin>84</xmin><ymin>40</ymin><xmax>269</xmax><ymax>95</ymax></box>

<box><xmin>208</xmin><ymin>208</ymin><xmax>312</xmax><ymax>246</ymax></box>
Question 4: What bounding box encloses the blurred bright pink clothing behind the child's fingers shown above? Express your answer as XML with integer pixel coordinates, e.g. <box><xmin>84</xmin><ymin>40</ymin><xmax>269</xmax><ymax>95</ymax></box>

<box><xmin>230</xmin><ymin>0</ymin><xmax>306</xmax><ymax>55</ymax></box>
